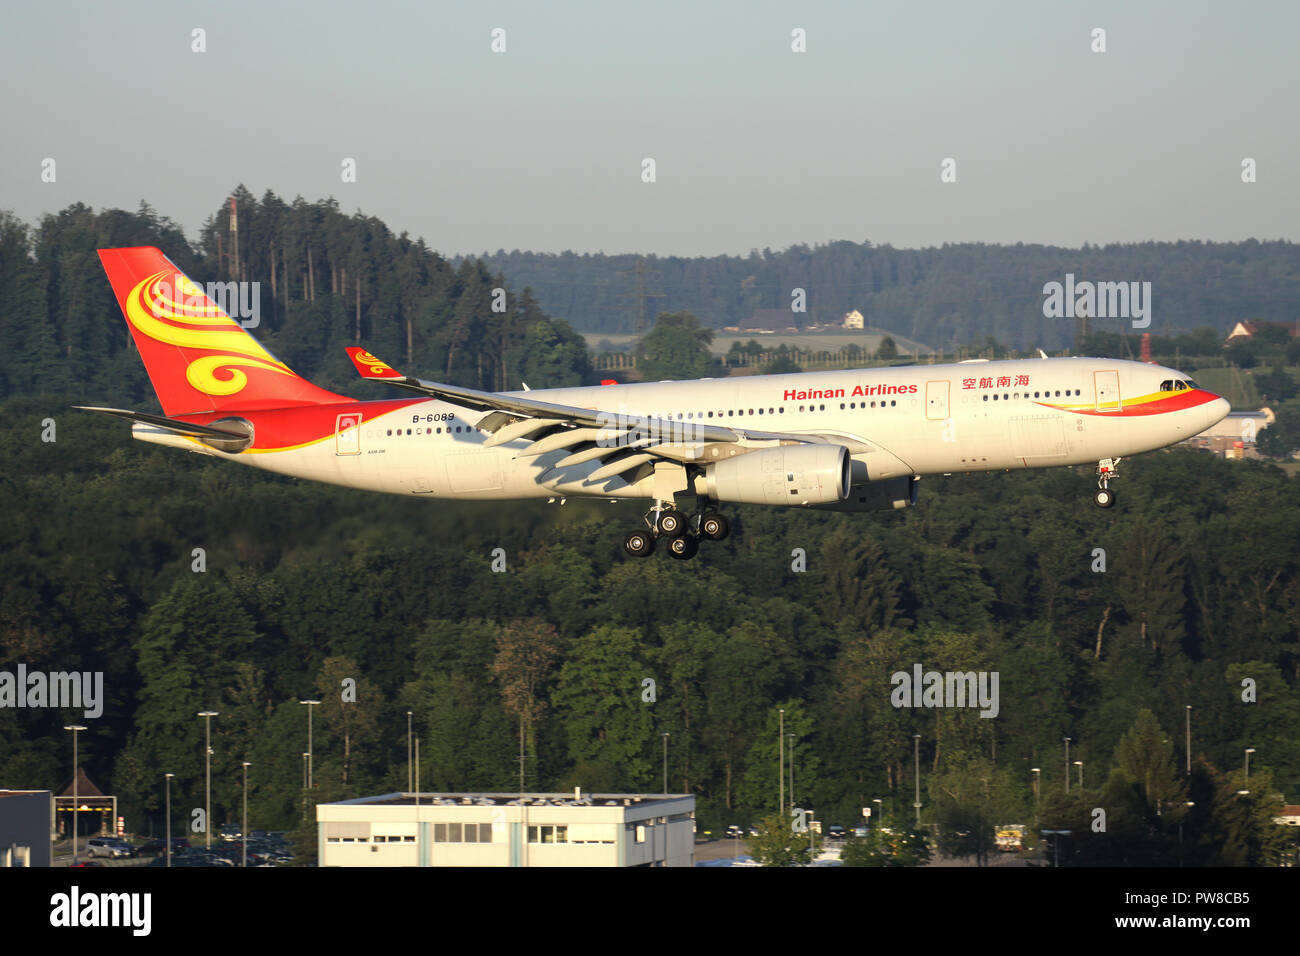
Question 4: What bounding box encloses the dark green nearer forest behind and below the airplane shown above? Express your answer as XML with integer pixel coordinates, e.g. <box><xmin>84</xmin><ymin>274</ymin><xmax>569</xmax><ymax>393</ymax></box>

<box><xmin>0</xmin><ymin>194</ymin><xmax>1300</xmax><ymax>864</ymax></box>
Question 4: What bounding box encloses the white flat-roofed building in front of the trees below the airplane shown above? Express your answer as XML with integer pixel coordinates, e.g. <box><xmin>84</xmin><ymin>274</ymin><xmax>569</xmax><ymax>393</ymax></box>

<box><xmin>316</xmin><ymin>790</ymin><xmax>696</xmax><ymax>866</ymax></box>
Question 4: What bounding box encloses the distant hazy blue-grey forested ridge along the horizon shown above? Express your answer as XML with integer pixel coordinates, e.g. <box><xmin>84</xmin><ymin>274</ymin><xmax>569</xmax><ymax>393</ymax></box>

<box><xmin>481</xmin><ymin>239</ymin><xmax>1300</xmax><ymax>351</ymax></box>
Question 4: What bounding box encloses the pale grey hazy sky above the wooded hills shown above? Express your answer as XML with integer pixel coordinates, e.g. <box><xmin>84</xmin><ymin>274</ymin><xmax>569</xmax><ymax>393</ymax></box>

<box><xmin>0</xmin><ymin>0</ymin><xmax>1300</xmax><ymax>255</ymax></box>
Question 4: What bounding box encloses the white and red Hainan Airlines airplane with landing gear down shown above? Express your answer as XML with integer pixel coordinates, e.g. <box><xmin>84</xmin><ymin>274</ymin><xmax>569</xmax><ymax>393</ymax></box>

<box><xmin>77</xmin><ymin>247</ymin><xmax>1230</xmax><ymax>559</ymax></box>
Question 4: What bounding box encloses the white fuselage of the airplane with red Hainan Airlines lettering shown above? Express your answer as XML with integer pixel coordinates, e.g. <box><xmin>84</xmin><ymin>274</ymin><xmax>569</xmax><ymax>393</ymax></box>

<box><xmin>135</xmin><ymin>358</ymin><xmax>1229</xmax><ymax>499</ymax></box>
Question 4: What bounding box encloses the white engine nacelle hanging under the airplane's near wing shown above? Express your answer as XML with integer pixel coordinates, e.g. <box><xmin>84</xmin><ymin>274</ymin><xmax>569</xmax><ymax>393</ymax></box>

<box><xmin>696</xmin><ymin>445</ymin><xmax>853</xmax><ymax>506</ymax></box>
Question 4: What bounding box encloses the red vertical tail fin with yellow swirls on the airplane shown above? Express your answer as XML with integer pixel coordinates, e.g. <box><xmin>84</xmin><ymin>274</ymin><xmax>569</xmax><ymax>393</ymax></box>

<box><xmin>99</xmin><ymin>246</ymin><xmax>351</xmax><ymax>416</ymax></box>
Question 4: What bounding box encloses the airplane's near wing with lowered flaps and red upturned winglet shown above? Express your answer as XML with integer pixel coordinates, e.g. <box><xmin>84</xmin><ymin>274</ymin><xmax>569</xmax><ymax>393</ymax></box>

<box><xmin>347</xmin><ymin>347</ymin><xmax>832</xmax><ymax>484</ymax></box>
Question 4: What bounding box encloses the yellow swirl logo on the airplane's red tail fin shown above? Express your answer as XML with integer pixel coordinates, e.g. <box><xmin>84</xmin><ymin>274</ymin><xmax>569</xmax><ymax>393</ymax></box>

<box><xmin>125</xmin><ymin>272</ymin><xmax>293</xmax><ymax>395</ymax></box>
